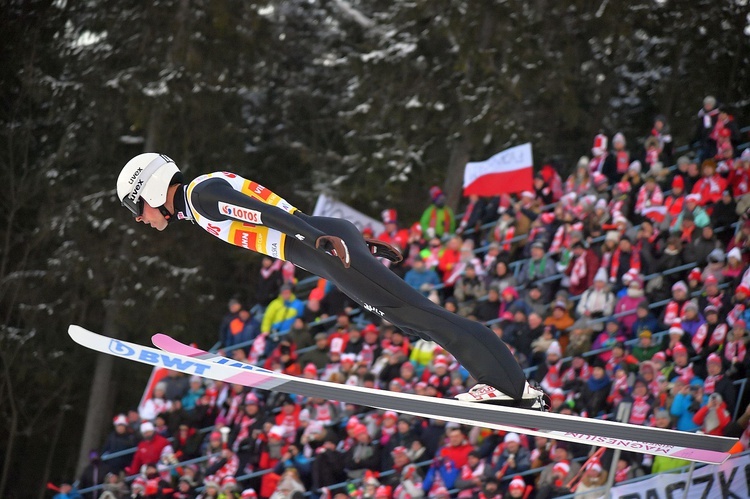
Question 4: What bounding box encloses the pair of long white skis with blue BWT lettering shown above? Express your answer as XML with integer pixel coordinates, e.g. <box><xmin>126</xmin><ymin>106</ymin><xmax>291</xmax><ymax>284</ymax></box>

<box><xmin>68</xmin><ymin>325</ymin><xmax>737</xmax><ymax>464</ymax></box>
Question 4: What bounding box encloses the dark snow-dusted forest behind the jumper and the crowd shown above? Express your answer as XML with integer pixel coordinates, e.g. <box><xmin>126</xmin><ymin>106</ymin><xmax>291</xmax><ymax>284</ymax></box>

<box><xmin>0</xmin><ymin>0</ymin><xmax>750</xmax><ymax>497</ymax></box>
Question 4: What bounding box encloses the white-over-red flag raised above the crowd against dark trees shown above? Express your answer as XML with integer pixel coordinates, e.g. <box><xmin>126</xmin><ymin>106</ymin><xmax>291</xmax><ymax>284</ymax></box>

<box><xmin>464</xmin><ymin>143</ymin><xmax>534</xmax><ymax>196</ymax></box>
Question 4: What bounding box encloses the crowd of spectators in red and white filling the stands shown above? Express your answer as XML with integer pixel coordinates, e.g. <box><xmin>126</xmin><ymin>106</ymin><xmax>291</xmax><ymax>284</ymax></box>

<box><xmin>58</xmin><ymin>97</ymin><xmax>750</xmax><ymax>499</ymax></box>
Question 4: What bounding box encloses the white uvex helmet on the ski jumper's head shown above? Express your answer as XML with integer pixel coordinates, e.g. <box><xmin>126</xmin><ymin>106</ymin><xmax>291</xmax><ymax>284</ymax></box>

<box><xmin>117</xmin><ymin>152</ymin><xmax>180</xmax><ymax>217</ymax></box>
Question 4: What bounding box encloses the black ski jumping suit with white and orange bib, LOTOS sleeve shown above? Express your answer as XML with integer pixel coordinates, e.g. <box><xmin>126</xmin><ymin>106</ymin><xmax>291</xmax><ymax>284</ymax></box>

<box><xmin>183</xmin><ymin>172</ymin><xmax>526</xmax><ymax>399</ymax></box>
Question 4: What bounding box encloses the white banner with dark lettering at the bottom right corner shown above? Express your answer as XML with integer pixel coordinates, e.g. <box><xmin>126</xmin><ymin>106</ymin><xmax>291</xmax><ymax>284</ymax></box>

<box><xmin>610</xmin><ymin>454</ymin><xmax>750</xmax><ymax>499</ymax></box>
